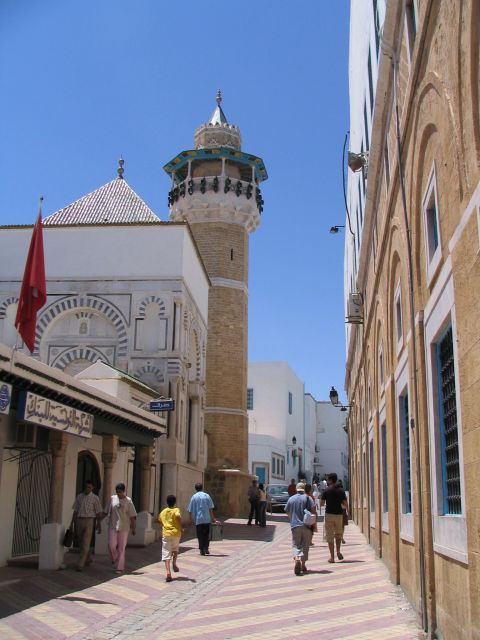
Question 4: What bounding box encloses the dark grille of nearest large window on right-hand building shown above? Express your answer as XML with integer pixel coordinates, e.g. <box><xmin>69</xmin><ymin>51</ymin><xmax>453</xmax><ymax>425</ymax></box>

<box><xmin>438</xmin><ymin>327</ymin><xmax>462</xmax><ymax>514</ymax></box>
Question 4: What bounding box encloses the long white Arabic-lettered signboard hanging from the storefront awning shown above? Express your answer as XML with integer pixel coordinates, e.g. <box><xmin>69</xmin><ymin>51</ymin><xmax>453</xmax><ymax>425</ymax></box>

<box><xmin>18</xmin><ymin>391</ymin><xmax>93</xmax><ymax>438</ymax></box>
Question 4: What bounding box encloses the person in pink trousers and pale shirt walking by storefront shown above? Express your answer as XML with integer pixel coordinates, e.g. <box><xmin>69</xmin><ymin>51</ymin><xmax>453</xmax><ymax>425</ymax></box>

<box><xmin>105</xmin><ymin>482</ymin><xmax>137</xmax><ymax>573</ymax></box>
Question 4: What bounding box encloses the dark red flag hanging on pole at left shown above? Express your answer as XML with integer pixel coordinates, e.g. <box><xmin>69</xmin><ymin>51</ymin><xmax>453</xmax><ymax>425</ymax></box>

<box><xmin>15</xmin><ymin>198</ymin><xmax>47</xmax><ymax>353</ymax></box>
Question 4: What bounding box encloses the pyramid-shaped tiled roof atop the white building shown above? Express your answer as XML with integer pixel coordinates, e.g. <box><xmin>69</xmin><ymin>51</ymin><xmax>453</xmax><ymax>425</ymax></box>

<box><xmin>43</xmin><ymin>178</ymin><xmax>160</xmax><ymax>226</ymax></box>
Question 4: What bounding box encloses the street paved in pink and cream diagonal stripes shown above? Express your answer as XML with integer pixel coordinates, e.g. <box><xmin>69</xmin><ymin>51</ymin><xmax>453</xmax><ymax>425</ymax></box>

<box><xmin>0</xmin><ymin>515</ymin><xmax>423</xmax><ymax>640</ymax></box>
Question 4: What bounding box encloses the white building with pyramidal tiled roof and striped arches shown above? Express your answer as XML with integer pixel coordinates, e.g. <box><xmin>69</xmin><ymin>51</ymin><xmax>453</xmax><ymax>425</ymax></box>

<box><xmin>0</xmin><ymin>171</ymin><xmax>210</xmax><ymax>514</ymax></box>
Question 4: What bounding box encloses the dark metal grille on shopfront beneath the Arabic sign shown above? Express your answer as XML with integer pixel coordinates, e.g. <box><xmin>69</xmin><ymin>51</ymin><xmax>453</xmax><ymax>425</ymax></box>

<box><xmin>12</xmin><ymin>451</ymin><xmax>51</xmax><ymax>557</ymax></box>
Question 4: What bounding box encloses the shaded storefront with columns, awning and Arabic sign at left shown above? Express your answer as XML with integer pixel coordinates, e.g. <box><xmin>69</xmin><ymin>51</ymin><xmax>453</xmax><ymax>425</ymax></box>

<box><xmin>0</xmin><ymin>345</ymin><xmax>165</xmax><ymax>568</ymax></box>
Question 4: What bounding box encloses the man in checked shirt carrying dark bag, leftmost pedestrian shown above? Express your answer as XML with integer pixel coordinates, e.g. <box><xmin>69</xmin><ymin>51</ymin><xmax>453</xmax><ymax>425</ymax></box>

<box><xmin>72</xmin><ymin>480</ymin><xmax>103</xmax><ymax>571</ymax></box>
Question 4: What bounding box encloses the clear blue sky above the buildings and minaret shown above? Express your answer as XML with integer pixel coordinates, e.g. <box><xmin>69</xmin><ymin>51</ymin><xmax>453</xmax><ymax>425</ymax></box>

<box><xmin>0</xmin><ymin>0</ymin><xmax>349</xmax><ymax>399</ymax></box>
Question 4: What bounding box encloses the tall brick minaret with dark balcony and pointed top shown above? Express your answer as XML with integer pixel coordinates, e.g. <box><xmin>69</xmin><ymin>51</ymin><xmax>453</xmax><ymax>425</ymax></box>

<box><xmin>164</xmin><ymin>91</ymin><xmax>267</xmax><ymax>515</ymax></box>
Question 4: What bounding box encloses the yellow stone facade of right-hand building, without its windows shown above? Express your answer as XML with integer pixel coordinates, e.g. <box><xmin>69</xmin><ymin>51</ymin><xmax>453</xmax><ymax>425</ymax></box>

<box><xmin>346</xmin><ymin>0</ymin><xmax>480</xmax><ymax>640</ymax></box>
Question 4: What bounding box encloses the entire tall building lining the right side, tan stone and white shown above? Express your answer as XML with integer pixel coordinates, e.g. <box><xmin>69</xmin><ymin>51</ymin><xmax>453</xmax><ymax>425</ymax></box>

<box><xmin>345</xmin><ymin>0</ymin><xmax>480</xmax><ymax>640</ymax></box>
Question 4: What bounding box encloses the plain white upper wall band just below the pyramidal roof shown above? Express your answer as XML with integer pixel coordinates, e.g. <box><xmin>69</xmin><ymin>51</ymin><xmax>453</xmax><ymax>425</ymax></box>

<box><xmin>0</xmin><ymin>223</ymin><xmax>209</xmax><ymax>322</ymax></box>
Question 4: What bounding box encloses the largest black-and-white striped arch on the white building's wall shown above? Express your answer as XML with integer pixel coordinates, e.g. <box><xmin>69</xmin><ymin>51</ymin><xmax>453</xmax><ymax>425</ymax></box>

<box><xmin>34</xmin><ymin>295</ymin><xmax>128</xmax><ymax>358</ymax></box>
